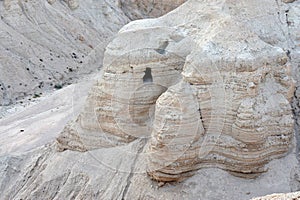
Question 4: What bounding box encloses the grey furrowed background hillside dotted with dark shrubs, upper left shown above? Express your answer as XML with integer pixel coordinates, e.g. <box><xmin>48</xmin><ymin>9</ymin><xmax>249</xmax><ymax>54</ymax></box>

<box><xmin>0</xmin><ymin>0</ymin><xmax>129</xmax><ymax>106</ymax></box>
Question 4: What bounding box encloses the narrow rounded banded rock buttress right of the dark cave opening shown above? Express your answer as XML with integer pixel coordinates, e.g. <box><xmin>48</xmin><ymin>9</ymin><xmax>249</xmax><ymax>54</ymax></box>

<box><xmin>148</xmin><ymin>82</ymin><xmax>204</xmax><ymax>182</ymax></box>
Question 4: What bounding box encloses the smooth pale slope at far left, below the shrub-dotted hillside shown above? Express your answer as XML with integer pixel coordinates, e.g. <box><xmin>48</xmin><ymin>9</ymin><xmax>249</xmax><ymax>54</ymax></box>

<box><xmin>0</xmin><ymin>74</ymin><xmax>95</xmax><ymax>156</ymax></box>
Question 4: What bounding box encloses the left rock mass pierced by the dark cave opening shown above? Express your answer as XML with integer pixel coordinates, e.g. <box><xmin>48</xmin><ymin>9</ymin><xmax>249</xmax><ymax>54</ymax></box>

<box><xmin>58</xmin><ymin>28</ymin><xmax>189</xmax><ymax>150</ymax></box>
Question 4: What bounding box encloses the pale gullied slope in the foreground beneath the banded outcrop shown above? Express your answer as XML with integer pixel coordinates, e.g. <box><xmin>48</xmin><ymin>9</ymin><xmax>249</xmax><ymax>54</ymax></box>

<box><xmin>0</xmin><ymin>139</ymin><xmax>297</xmax><ymax>200</ymax></box>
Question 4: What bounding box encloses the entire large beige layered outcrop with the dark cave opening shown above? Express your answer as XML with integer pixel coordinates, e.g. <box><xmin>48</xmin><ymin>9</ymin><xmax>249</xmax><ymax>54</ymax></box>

<box><xmin>57</xmin><ymin>0</ymin><xmax>294</xmax><ymax>182</ymax></box>
